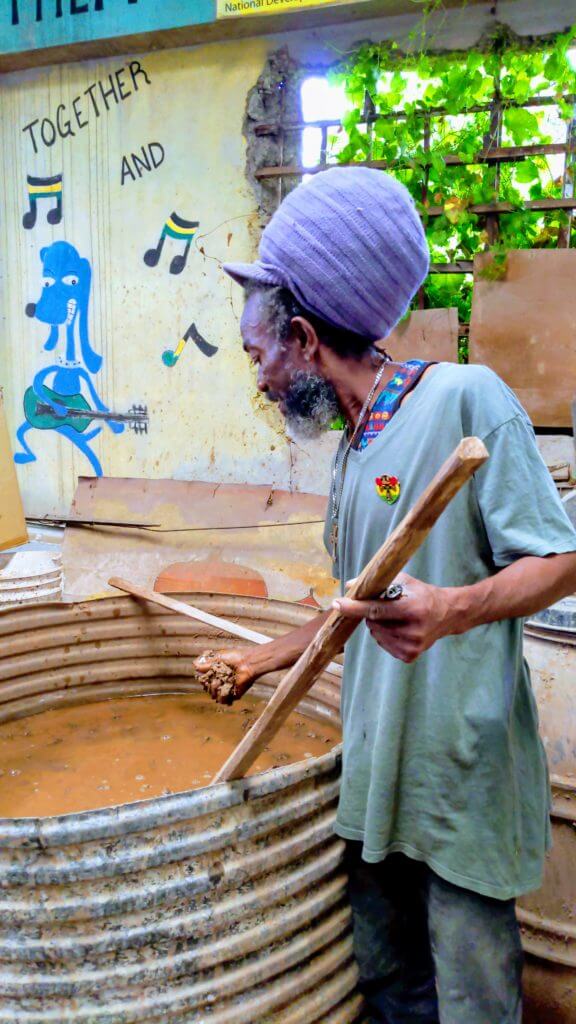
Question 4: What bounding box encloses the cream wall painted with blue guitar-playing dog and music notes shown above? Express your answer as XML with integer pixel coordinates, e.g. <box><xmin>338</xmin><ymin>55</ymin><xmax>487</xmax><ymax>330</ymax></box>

<box><xmin>0</xmin><ymin>39</ymin><xmax>334</xmax><ymax>515</ymax></box>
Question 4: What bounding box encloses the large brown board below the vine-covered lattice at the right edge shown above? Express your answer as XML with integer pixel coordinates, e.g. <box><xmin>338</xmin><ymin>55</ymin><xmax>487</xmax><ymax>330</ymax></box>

<box><xmin>469</xmin><ymin>249</ymin><xmax>576</xmax><ymax>428</ymax></box>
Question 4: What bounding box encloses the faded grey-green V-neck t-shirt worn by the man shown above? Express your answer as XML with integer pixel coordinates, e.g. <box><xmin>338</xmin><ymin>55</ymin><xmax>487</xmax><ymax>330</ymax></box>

<box><xmin>326</xmin><ymin>364</ymin><xmax>576</xmax><ymax>899</ymax></box>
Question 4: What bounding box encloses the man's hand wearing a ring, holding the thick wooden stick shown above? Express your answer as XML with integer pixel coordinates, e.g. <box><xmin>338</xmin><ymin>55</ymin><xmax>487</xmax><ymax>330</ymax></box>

<box><xmin>332</xmin><ymin>572</ymin><xmax>454</xmax><ymax>664</ymax></box>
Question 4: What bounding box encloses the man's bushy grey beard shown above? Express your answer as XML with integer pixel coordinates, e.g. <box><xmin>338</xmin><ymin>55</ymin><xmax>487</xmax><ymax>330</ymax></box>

<box><xmin>284</xmin><ymin>370</ymin><xmax>340</xmax><ymax>440</ymax></box>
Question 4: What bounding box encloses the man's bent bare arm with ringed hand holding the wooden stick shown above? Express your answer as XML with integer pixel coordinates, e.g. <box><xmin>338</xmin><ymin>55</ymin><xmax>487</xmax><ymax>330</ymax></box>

<box><xmin>333</xmin><ymin>552</ymin><xmax>576</xmax><ymax>663</ymax></box>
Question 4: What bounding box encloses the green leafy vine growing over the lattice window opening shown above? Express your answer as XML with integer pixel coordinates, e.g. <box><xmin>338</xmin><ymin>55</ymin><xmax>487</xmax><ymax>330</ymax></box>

<box><xmin>329</xmin><ymin>18</ymin><xmax>576</xmax><ymax>348</ymax></box>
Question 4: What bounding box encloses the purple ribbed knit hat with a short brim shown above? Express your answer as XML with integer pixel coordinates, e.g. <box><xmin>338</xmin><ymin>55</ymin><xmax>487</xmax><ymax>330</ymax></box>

<box><xmin>223</xmin><ymin>167</ymin><xmax>429</xmax><ymax>341</ymax></box>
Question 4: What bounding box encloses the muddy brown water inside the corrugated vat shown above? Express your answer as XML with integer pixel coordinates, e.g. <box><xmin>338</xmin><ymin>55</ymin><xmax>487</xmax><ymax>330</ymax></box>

<box><xmin>0</xmin><ymin>693</ymin><xmax>340</xmax><ymax>818</ymax></box>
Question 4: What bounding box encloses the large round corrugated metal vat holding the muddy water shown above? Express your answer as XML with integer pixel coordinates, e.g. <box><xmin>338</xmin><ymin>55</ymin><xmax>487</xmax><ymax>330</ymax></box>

<box><xmin>0</xmin><ymin>594</ymin><xmax>361</xmax><ymax>1024</ymax></box>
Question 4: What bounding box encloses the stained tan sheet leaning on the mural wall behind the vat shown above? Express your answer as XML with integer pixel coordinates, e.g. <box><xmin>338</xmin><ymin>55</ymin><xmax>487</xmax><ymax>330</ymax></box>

<box><xmin>63</xmin><ymin>477</ymin><xmax>339</xmax><ymax>605</ymax></box>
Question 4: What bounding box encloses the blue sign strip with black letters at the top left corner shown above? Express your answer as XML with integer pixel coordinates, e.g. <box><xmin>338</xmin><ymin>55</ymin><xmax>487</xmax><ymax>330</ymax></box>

<box><xmin>0</xmin><ymin>0</ymin><xmax>216</xmax><ymax>54</ymax></box>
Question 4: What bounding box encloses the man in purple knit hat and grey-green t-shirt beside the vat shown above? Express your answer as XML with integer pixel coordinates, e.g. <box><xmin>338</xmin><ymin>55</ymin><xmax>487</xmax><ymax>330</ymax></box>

<box><xmin>198</xmin><ymin>168</ymin><xmax>576</xmax><ymax>1024</ymax></box>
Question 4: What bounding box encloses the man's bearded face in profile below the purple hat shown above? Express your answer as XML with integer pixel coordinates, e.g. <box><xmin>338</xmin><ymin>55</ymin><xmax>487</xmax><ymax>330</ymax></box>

<box><xmin>240</xmin><ymin>292</ymin><xmax>339</xmax><ymax>437</ymax></box>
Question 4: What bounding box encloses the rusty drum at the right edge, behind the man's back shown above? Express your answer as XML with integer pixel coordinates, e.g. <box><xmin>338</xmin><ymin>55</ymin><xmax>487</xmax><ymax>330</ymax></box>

<box><xmin>518</xmin><ymin>598</ymin><xmax>576</xmax><ymax>1024</ymax></box>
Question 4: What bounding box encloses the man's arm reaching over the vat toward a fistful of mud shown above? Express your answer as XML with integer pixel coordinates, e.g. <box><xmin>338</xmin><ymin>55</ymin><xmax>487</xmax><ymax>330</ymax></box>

<box><xmin>194</xmin><ymin>611</ymin><xmax>330</xmax><ymax>699</ymax></box>
